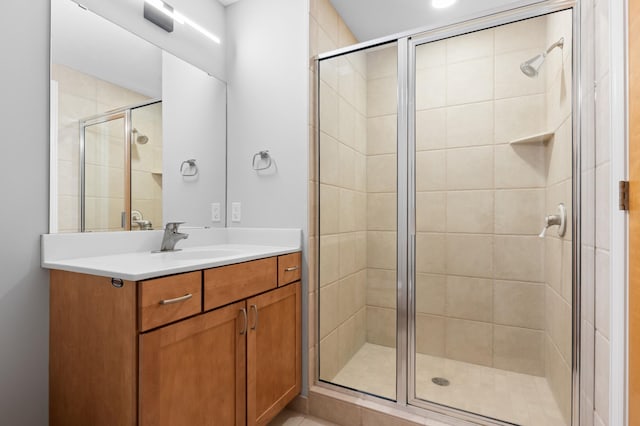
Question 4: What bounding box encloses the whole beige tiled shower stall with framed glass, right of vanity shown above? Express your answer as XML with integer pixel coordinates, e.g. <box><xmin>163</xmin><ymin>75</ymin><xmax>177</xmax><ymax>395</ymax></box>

<box><xmin>316</xmin><ymin>1</ymin><xmax>580</xmax><ymax>426</ymax></box>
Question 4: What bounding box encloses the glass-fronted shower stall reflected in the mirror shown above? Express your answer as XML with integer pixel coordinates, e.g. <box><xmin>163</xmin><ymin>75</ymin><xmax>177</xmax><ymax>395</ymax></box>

<box><xmin>79</xmin><ymin>100</ymin><xmax>162</xmax><ymax>232</ymax></box>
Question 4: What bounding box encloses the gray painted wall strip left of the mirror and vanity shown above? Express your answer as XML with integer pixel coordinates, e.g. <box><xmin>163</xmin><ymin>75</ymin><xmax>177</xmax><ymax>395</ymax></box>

<box><xmin>0</xmin><ymin>0</ymin><xmax>49</xmax><ymax>426</ymax></box>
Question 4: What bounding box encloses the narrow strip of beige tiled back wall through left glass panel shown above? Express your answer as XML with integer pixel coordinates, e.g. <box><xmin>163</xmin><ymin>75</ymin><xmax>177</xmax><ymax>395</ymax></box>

<box><xmin>366</xmin><ymin>43</ymin><xmax>398</xmax><ymax>347</ymax></box>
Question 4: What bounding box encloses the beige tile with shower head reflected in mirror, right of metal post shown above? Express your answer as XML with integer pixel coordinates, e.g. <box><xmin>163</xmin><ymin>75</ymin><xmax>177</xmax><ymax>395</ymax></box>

<box><xmin>131</xmin><ymin>103</ymin><xmax>163</xmax><ymax>230</ymax></box>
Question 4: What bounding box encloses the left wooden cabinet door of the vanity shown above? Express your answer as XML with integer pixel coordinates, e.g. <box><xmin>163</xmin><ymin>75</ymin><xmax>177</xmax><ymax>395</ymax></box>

<box><xmin>139</xmin><ymin>302</ymin><xmax>247</xmax><ymax>426</ymax></box>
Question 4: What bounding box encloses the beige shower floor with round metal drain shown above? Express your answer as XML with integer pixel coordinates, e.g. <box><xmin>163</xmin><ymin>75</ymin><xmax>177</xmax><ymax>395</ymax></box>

<box><xmin>332</xmin><ymin>343</ymin><xmax>566</xmax><ymax>426</ymax></box>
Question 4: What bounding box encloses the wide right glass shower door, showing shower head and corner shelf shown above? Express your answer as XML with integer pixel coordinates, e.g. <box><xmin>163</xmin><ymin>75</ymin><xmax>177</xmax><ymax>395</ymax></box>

<box><xmin>409</xmin><ymin>11</ymin><xmax>572</xmax><ymax>426</ymax></box>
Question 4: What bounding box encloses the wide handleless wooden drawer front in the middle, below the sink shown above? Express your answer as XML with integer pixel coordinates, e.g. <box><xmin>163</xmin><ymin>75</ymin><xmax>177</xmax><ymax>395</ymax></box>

<box><xmin>204</xmin><ymin>257</ymin><xmax>278</xmax><ymax>311</ymax></box>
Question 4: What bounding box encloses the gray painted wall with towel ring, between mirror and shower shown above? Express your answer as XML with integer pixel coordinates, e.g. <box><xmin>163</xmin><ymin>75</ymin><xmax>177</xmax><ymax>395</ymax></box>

<box><xmin>226</xmin><ymin>0</ymin><xmax>309</xmax><ymax>389</ymax></box>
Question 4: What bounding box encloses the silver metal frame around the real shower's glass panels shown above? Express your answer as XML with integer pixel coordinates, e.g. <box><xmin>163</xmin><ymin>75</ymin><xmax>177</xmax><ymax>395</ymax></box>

<box><xmin>315</xmin><ymin>0</ymin><xmax>582</xmax><ymax>426</ymax></box>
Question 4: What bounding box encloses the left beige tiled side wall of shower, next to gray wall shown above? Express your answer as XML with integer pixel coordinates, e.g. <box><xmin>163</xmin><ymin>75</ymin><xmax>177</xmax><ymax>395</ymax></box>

<box><xmin>309</xmin><ymin>0</ymin><xmax>367</xmax><ymax>380</ymax></box>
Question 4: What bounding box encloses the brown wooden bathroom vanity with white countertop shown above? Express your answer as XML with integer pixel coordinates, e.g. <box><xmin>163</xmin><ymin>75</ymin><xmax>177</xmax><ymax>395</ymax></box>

<box><xmin>43</xmin><ymin>230</ymin><xmax>301</xmax><ymax>426</ymax></box>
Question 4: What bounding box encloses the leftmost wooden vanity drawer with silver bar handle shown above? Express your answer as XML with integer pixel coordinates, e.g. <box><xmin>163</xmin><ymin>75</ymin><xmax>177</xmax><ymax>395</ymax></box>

<box><xmin>138</xmin><ymin>271</ymin><xmax>202</xmax><ymax>331</ymax></box>
